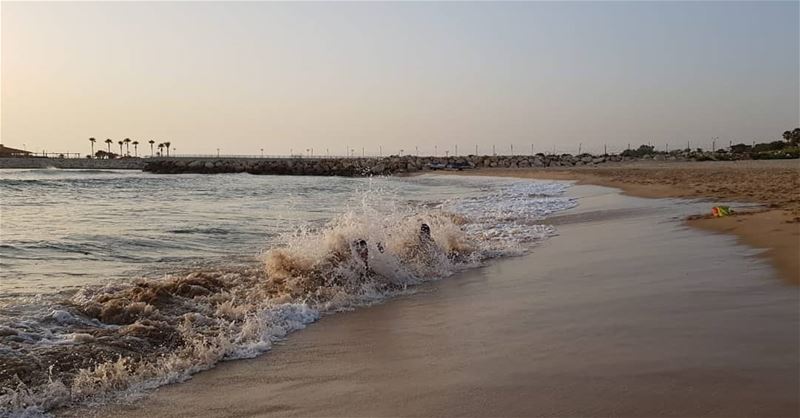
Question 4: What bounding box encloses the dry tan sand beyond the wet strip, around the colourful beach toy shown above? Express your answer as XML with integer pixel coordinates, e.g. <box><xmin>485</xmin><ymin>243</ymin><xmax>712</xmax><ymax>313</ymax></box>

<box><xmin>446</xmin><ymin>160</ymin><xmax>800</xmax><ymax>285</ymax></box>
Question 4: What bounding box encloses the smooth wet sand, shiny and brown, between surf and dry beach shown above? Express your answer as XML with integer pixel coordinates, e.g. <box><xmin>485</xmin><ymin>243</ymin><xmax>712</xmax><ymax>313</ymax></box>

<box><xmin>81</xmin><ymin>186</ymin><xmax>800</xmax><ymax>417</ymax></box>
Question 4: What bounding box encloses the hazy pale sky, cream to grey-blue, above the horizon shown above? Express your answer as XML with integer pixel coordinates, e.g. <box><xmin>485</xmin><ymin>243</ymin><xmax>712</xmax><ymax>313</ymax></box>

<box><xmin>0</xmin><ymin>1</ymin><xmax>800</xmax><ymax>155</ymax></box>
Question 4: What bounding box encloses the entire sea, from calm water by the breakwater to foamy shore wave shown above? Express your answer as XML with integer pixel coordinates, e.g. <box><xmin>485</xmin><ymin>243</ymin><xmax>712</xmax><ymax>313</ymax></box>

<box><xmin>0</xmin><ymin>170</ymin><xmax>575</xmax><ymax>414</ymax></box>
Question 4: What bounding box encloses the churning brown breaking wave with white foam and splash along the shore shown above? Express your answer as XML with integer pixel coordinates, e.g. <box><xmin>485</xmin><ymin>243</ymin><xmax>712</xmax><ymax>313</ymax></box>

<box><xmin>0</xmin><ymin>176</ymin><xmax>575</xmax><ymax>415</ymax></box>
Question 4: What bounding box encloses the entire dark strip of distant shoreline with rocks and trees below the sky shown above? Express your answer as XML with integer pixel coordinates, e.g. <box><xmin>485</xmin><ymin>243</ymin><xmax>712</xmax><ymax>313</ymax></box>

<box><xmin>0</xmin><ymin>140</ymin><xmax>800</xmax><ymax>177</ymax></box>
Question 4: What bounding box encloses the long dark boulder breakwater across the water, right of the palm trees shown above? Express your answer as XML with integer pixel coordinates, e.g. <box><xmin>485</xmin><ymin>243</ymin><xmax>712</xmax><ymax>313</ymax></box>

<box><xmin>144</xmin><ymin>154</ymin><xmax>652</xmax><ymax>177</ymax></box>
